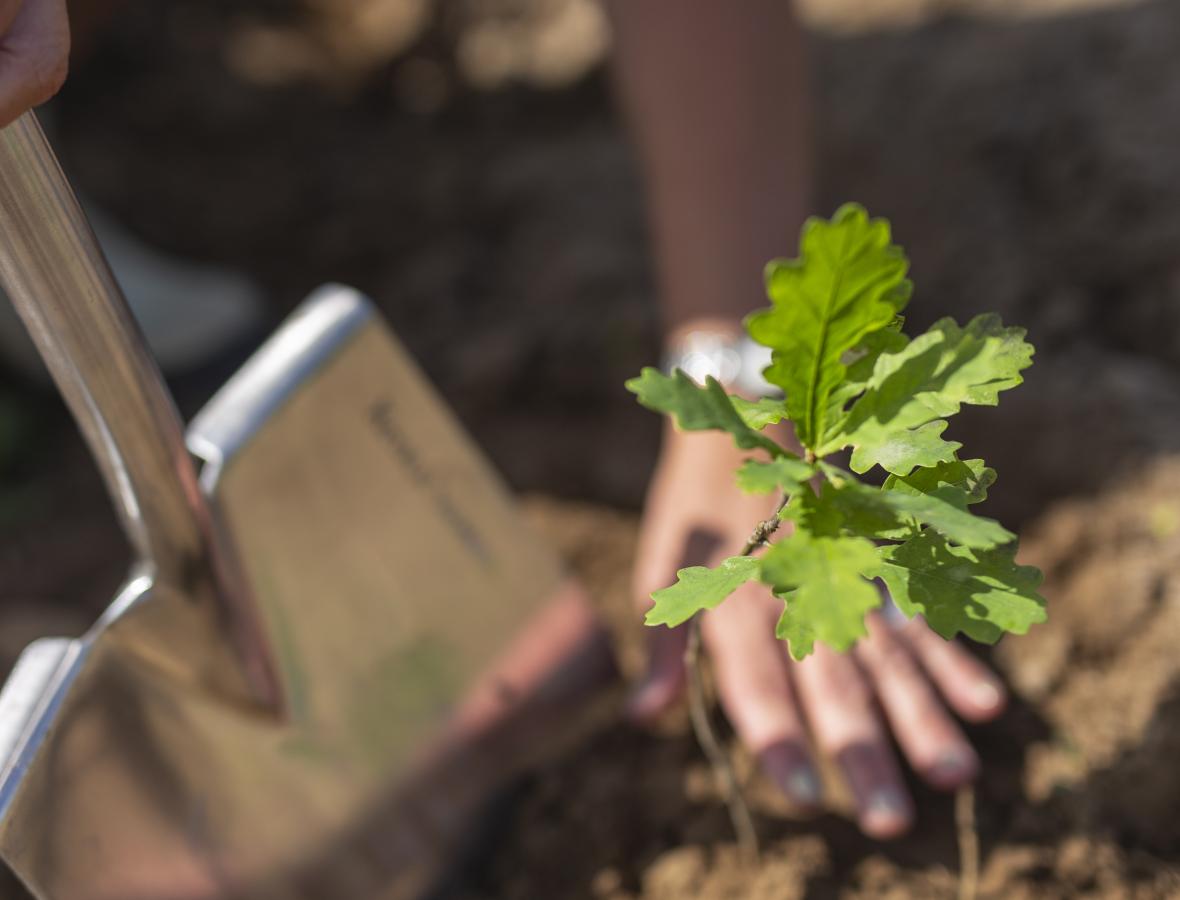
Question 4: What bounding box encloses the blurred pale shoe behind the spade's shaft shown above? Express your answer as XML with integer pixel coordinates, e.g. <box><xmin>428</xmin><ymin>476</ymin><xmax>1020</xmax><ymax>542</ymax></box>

<box><xmin>0</xmin><ymin>201</ymin><xmax>264</xmax><ymax>381</ymax></box>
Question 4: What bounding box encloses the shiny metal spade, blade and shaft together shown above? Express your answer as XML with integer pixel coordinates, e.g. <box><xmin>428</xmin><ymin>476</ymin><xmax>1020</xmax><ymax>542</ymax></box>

<box><xmin>0</xmin><ymin>114</ymin><xmax>612</xmax><ymax>900</ymax></box>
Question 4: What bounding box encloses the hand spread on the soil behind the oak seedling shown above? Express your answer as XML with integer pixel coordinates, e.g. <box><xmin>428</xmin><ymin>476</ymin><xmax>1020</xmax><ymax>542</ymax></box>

<box><xmin>630</xmin><ymin>431</ymin><xmax>1004</xmax><ymax>837</ymax></box>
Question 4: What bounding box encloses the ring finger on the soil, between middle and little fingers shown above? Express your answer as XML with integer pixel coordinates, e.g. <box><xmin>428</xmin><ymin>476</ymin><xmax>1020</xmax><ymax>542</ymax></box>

<box><xmin>856</xmin><ymin>615</ymin><xmax>979</xmax><ymax>790</ymax></box>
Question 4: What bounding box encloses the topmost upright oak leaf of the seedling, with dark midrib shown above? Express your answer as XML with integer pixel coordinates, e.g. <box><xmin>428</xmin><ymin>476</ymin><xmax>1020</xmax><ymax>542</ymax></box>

<box><xmin>746</xmin><ymin>204</ymin><xmax>911</xmax><ymax>448</ymax></box>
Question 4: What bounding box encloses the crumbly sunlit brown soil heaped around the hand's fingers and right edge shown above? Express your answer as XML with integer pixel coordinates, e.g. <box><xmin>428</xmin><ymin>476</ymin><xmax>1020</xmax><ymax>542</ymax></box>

<box><xmin>448</xmin><ymin>456</ymin><xmax>1180</xmax><ymax>900</ymax></box>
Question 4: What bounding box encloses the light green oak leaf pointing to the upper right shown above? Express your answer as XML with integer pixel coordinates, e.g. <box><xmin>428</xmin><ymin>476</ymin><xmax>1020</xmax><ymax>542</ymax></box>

<box><xmin>817</xmin><ymin>315</ymin><xmax>1033</xmax><ymax>475</ymax></box>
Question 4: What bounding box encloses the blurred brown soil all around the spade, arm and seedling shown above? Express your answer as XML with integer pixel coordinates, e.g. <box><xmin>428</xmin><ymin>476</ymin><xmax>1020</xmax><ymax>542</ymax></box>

<box><xmin>0</xmin><ymin>0</ymin><xmax>1180</xmax><ymax>898</ymax></box>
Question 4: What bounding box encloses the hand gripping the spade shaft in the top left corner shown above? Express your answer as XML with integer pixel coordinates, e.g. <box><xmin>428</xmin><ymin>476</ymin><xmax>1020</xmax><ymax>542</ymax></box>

<box><xmin>0</xmin><ymin>0</ymin><xmax>70</xmax><ymax>126</ymax></box>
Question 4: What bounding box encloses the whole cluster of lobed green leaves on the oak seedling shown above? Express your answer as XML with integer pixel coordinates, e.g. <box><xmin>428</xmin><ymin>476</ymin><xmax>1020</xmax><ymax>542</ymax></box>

<box><xmin>627</xmin><ymin>204</ymin><xmax>1045</xmax><ymax>659</ymax></box>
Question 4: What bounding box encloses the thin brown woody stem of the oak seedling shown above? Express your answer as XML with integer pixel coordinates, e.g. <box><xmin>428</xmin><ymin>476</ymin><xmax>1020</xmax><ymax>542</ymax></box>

<box><xmin>684</xmin><ymin>494</ymin><xmax>789</xmax><ymax>862</ymax></box>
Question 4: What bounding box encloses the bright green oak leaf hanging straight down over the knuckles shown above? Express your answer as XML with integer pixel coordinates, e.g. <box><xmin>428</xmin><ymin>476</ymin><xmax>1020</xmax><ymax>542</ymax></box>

<box><xmin>760</xmin><ymin>532</ymin><xmax>881</xmax><ymax>659</ymax></box>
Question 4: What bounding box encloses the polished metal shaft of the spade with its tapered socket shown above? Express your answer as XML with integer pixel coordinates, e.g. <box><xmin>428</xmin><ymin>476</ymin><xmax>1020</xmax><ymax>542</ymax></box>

<box><xmin>0</xmin><ymin>112</ymin><xmax>282</xmax><ymax>707</ymax></box>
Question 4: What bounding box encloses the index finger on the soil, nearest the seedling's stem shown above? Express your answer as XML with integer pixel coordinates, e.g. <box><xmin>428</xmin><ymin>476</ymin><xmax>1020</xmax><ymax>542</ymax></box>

<box><xmin>704</xmin><ymin>585</ymin><xmax>821</xmax><ymax>809</ymax></box>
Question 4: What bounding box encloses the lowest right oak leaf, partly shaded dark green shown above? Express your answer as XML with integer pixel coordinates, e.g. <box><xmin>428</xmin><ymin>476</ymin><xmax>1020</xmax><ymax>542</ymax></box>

<box><xmin>874</xmin><ymin>531</ymin><xmax>1045</xmax><ymax>644</ymax></box>
